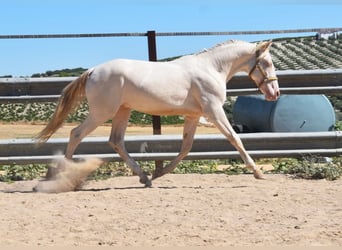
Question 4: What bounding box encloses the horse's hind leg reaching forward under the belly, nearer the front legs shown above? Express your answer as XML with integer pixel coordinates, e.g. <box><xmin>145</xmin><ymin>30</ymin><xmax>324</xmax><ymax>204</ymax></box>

<box><xmin>109</xmin><ymin>107</ymin><xmax>152</xmax><ymax>187</ymax></box>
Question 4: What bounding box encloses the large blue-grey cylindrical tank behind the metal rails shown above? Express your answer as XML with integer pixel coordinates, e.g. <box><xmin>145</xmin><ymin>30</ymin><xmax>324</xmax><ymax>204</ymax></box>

<box><xmin>233</xmin><ymin>95</ymin><xmax>336</xmax><ymax>132</ymax></box>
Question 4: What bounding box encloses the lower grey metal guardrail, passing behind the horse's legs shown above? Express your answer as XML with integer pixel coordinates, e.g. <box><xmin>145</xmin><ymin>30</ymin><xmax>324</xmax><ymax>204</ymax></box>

<box><xmin>0</xmin><ymin>131</ymin><xmax>342</xmax><ymax>164</ymax></box>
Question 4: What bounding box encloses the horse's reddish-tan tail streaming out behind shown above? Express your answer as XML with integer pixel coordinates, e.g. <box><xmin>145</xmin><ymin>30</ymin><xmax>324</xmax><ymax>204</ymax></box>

<box><xmin>37</xmin><ymin>71</ymin><xmax>89</xmax><ymax>143</ymax></box>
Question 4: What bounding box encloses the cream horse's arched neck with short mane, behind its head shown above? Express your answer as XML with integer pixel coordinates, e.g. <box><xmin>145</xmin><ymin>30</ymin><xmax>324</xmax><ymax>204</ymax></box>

<box><xmin>202</xmin><ymin>43</ymin><xmax>254</xmax><ymax>81</ymax></box>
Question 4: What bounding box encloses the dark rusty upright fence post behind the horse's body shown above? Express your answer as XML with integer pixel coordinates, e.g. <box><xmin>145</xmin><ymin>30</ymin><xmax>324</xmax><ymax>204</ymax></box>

<box><xmin>147</xmin><ymin>30</ymin><xmax>163</xmax><ymax>176</ymax></box>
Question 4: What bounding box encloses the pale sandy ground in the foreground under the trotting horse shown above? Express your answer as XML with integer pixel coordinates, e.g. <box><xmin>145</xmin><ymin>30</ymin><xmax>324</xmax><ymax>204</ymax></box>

<box><xmin>0</xmin><ymin>174</ymin><xmax>342</xmax><ymax>246</ymax></box>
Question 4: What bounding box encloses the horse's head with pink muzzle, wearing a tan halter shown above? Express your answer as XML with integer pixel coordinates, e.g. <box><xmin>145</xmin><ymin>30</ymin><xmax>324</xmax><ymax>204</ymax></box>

<box><xmin>249</xmin><ymin>42</ymin><xmax>280</xmax><ymax>101</ymax></box>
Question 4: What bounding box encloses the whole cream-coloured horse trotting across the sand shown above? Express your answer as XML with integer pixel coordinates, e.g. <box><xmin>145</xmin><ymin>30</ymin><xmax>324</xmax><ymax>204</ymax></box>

<box><xmin>37</xmin><ymin>40</ymin><xmax>280</xmax><ymax>187</ymax></box>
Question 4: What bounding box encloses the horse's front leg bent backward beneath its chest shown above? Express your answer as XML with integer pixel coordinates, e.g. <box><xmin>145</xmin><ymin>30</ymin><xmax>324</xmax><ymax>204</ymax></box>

<box><xmin>152</xmin><ymin>117</ymin><xmax>199</xmax><ymax>179</ymax></box>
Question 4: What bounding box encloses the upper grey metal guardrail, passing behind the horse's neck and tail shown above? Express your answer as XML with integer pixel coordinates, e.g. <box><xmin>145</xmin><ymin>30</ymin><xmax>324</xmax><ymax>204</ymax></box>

<box><xmin>0</xmin><ymin>69</ymin><xmax>342</xmax><ymax>103</ymax></box>
